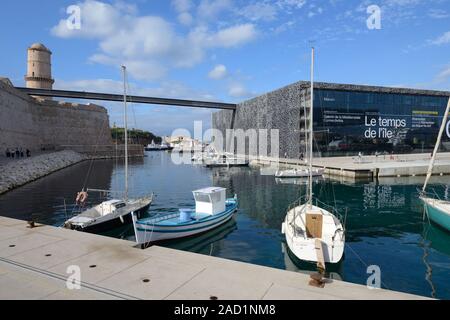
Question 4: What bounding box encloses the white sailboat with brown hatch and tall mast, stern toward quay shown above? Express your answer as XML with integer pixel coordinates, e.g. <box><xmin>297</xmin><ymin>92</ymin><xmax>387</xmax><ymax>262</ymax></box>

<box><xmin>281</xmin><ymin>48</ymin><xmax>345</xmax><ymax>270</ymax></box>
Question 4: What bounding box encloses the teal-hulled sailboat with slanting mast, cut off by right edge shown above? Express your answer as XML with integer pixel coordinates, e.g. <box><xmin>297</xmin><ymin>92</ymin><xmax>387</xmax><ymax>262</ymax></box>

<box><xmin>419</xmin><ymin>98</ymin><xmax>450</xmax><ymax>231</ymax></box>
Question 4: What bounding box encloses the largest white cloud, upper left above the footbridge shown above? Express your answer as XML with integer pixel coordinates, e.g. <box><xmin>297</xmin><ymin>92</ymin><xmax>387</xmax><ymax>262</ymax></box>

<box><xmin>52</xmin><ymin>0</ymin><xmax>258</xmax><ymax>80</ymax></box>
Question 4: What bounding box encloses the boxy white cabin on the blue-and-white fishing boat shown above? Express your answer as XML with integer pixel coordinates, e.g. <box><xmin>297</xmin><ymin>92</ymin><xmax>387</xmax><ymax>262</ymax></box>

<box><xmin>192</xmin><ymin>187</ymin><xmax>227</xmax><ymax>215</ymax></box>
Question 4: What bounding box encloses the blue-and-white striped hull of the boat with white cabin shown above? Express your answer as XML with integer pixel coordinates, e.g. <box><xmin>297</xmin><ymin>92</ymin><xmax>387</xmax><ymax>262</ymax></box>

<box><xmin>133</xmin><ymin>203</ymin><xmax>237</xmax><ymax>244</ymax></box>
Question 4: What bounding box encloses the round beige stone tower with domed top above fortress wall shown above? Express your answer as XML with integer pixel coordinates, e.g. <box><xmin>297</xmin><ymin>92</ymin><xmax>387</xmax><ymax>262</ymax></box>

<box><xmin>25</xmin><ymin>43</ymin><xmax>55</xmax><ymax>89</ymax></box>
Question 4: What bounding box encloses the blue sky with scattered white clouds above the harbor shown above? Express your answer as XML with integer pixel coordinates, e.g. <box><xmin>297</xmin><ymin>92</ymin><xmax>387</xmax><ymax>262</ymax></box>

<box><xmin>0</xmin><ymin>0</ymin><xmax>450</xmax><ymax>135</ymax></box>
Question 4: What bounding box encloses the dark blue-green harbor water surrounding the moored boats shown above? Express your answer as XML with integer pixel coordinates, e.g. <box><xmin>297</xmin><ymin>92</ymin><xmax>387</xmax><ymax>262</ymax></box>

<box><xmin>0</xmin><ymin>152</ymin><xmax>450</xmax><ymax>299</ymax></box>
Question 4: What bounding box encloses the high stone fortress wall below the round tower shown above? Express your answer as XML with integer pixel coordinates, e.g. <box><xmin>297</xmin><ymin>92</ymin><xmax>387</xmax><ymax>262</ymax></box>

<box><xmin>0</xmin><ymin>79</ymin><xmax>112</xmax><ymax>153</ymax></box>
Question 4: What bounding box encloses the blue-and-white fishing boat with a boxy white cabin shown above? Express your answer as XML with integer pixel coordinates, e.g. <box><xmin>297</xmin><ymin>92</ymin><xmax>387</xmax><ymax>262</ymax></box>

<box><xmin>133</xmin><ymin>187</ymin><xmax>238</xmax><ymax>244</ymax></box>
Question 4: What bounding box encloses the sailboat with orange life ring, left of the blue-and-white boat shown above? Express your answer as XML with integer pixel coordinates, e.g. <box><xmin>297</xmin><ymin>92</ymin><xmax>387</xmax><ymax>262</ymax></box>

<box><xmin>64</xmin><ymin>66</ymin><xmax>153</xmax><ymax>232</ymax></box>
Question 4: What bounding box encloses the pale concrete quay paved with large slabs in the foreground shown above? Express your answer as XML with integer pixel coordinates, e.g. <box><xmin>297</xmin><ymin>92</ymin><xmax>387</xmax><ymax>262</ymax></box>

<box><xmin>0</xmin><ymin>217</ymin><xmax>427</xmax><ymax>300</ymax></box>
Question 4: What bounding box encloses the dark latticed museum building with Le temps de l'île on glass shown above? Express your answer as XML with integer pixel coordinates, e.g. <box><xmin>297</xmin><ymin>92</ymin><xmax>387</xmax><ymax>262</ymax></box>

<box><xmin>212</xmin><ymin>81</ymin><xmax>450</xmax><ymax>158</ymax></box>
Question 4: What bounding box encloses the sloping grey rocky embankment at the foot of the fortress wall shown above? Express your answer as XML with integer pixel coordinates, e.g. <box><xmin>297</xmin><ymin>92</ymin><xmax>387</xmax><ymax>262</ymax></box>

<box><xmin>0</xmin><ymin>151</ymin><xmax>88</xmax><ymax>194</ymax></box>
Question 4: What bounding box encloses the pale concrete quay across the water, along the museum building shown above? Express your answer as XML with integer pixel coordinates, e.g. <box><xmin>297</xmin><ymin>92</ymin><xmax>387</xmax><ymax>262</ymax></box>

<box><xmin>252</xmin><ymin>152</ymin><xmax>450</xmax><ymax>182</ymax></box>
